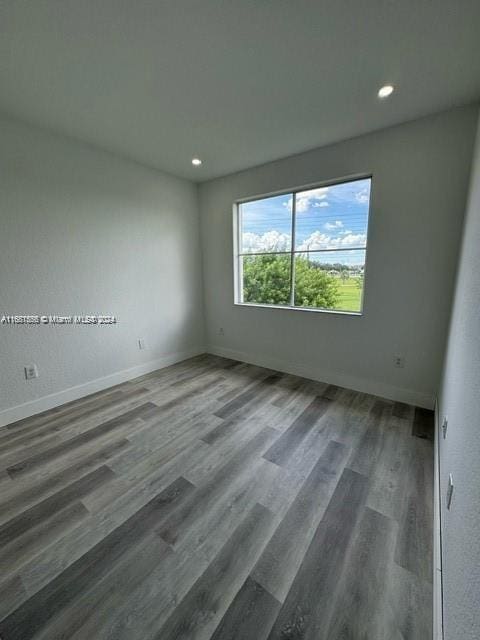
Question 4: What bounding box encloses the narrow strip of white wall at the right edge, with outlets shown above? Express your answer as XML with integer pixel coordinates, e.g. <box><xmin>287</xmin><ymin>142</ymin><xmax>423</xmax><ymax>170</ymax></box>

<box><xmin>438</xmin><ymin>111</ymin><xmax>480</xmax><ymax>640</ymax></box>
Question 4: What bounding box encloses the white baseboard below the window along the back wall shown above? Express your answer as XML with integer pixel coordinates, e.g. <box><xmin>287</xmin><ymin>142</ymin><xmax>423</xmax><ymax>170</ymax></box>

<box><xmin>207</xmin><ymin>345</ymin><xmax>434</xmax><ymax>409</ymax></box>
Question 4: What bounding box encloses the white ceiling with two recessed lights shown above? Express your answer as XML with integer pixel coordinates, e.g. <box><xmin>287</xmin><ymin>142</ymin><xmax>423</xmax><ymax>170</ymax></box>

<box><xmin>0</xmin><ymin>0</ymin><xmax>480</xmax><ymax>180</ymax></box>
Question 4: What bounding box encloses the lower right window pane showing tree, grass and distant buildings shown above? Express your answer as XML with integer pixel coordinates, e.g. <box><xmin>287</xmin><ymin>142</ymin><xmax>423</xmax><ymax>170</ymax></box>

<box><xmin>295</xmin><ymin>249</ymin><xmax>365</xmax><ymax>312</ymax></box>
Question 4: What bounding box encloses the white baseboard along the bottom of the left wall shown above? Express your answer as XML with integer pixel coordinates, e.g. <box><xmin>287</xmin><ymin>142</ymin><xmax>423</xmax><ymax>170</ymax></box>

<box><xmin>0</xmin><ymin>347</ymin><xmax>205</xmax><ymax>427</ymax></box>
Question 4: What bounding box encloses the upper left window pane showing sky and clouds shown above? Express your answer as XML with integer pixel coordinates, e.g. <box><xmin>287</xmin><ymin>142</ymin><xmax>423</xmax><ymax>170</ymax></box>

<box><xmin>239</xmin><ymin>194</ymin><xmax>292</xmax><ymax>253</ymax></box>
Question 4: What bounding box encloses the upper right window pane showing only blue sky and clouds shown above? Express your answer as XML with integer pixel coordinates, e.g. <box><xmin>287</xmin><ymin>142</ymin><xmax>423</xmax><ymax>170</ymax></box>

<box><xmin>295</xmin><ymin>178</ymin><xmax>371</xmax><ymax>251</ymax></box>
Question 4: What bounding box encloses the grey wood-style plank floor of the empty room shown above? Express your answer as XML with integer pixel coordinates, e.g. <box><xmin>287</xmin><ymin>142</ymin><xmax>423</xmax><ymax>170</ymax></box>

<box><xmin>0</xmin><ymin>356</ymin><xmax>433</xmax><ymax>640</ymax></box>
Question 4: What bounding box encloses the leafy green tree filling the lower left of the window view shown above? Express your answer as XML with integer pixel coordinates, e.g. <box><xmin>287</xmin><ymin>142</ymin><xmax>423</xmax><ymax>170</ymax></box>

<box><xmin>243</xmin><ymin>255</ymin><xmax>338</xmax><ymax>309</ymax></box>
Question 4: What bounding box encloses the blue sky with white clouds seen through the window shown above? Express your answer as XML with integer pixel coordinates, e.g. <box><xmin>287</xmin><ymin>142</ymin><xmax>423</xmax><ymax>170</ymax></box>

<box><xmin>241</xmin><ymin>178</ymin><xmax>371</xmax><ymax>264</ymax></box>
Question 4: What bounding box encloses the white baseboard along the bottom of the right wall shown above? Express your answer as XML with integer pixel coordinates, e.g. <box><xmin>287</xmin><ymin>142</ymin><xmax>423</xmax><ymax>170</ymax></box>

<box><xmin>433</xmin><ymin>401</ymin><xmax>444</xmax><ymax>640</ymax></box>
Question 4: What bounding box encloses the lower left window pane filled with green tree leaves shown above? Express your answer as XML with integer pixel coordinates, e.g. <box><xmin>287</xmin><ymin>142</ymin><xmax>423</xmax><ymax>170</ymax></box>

<box><xmin>240</xmin><ymin>254</ymin><xmax>291</xmax><ymax>305</ymax></box>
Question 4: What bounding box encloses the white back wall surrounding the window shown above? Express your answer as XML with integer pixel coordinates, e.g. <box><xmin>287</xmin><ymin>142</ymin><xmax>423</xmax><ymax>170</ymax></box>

<box><xmin>200</xmin><ymin>107</ymin><xmax>477</xmax><ymax>406</ymax></box>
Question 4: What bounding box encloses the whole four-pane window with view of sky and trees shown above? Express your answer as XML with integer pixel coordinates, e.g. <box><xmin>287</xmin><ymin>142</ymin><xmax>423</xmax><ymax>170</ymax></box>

<box><xmin>235</xmin><ymin>178</ymin><xmax>371</xmax><ymax>313</ymax></box>
